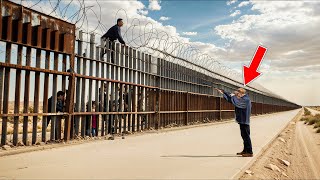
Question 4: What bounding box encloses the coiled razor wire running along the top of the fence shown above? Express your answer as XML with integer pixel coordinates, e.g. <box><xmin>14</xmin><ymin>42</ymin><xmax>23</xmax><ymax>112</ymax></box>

<box><xmin>15</xmin><ymin>0</ymin><xmax>276</xmax><ymax>96</ymax></box>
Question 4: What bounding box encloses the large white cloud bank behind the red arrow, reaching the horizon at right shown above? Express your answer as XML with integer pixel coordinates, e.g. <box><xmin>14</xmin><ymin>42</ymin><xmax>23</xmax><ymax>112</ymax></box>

<box><xmin>214</xmin><ymin>1</ymin><xmax>320</xmax><ymax>105</ymax></box>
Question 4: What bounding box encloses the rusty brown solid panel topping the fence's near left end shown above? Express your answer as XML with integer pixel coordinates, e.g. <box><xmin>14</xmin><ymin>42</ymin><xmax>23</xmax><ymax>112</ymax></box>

<box><xmin>0</xmin><ymin>0</ymin><xmax>75</xmax><ymax>54</ymax></box>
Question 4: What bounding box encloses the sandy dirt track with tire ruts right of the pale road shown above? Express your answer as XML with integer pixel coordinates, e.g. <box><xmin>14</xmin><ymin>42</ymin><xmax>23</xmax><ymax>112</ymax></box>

<box><xmin>240</xmin><ymin>110</ymin><xmax>320</xmax><ymax>179</ymax></box>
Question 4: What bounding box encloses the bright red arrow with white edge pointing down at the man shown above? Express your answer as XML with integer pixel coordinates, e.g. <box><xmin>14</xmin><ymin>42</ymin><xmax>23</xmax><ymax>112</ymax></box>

<box><xmin>243</xmin><ymin>46</ymin><xmax>267</xmax><ymax>86</ymax></box>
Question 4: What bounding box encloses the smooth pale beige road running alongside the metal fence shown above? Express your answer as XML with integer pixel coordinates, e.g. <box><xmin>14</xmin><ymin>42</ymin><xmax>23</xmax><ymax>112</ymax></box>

<box><xmin>0</xmin><ymin>110</ymin><xmax>299</xmax><ymax>179</ymax></box>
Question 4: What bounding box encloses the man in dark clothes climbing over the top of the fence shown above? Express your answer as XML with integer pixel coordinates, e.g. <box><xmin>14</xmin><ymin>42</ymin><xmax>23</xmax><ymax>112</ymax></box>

<box><xmin>101</xmin><ymin>18</ymin><xmax>126</xmax><ymax>63</ymax></box>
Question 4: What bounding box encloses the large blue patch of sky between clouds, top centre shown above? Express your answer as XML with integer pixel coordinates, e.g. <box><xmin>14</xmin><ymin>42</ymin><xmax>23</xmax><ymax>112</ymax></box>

<box><xmin>141</xmin><ymin>0</ymin><xmax>254</xmax><ymax>46</ymax></box>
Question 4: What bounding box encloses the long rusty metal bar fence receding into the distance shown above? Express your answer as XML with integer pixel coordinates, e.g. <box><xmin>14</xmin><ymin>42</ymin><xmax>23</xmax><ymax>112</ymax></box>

<box><xmin>0</xmin><ymin>1</ymin><xmax>300</xmax><ymax>145</ymax></box>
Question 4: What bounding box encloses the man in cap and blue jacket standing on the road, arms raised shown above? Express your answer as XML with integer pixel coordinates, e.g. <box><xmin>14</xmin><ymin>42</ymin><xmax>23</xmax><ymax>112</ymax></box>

<box><xmin>217</xmin><ymin>88</ymin><xmax>253</xmax><ymax>157</ymax></box>
